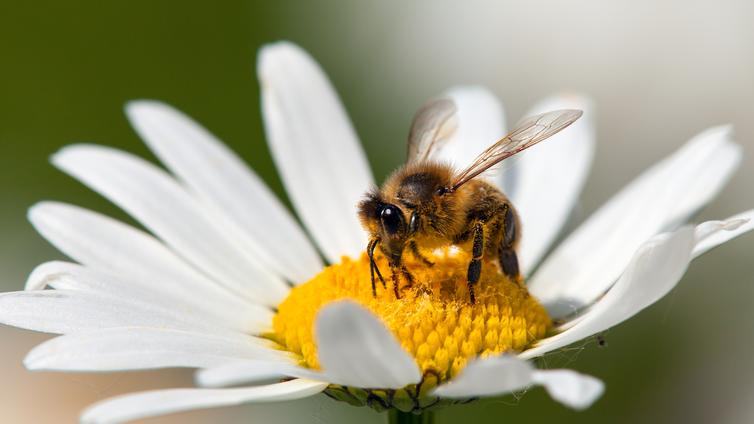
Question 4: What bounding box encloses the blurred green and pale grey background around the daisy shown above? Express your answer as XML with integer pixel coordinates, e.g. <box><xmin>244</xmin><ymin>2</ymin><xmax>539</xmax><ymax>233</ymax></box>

<box><xmin>0</xmin><ymin>0</ymin><xmax>754</xmax><ymax>424</ymax></box>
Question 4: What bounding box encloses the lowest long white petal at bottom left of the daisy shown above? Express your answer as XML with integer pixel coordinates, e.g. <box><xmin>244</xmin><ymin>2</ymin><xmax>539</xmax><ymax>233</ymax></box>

<box><xmin>81</xmin><ymin>380</ymin><xmax>327</xmax><ymax>424</ymax></box>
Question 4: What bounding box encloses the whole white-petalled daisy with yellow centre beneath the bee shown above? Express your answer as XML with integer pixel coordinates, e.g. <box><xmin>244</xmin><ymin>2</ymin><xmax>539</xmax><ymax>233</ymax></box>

<box><xmin>0</xmin><ymin>43</ymin><xmax>754</xmax><ymax>423</ymax></box>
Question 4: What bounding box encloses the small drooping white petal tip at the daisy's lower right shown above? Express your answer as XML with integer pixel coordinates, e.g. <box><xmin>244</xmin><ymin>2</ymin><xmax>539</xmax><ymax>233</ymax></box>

<box><xmin>532</xmin><ymin>370</ymin><xmax>605</xmax><ymax>410</ymax></box>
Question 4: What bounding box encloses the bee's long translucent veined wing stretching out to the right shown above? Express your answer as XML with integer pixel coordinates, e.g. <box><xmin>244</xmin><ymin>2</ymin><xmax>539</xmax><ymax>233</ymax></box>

<box><xmin>451</xmin><ymin>109</ymin><xmax>583</xmax><ymax>190</ymax></box>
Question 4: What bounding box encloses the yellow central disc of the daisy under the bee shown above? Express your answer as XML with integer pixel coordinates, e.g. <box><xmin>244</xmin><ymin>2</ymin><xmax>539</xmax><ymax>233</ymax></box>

<box><xmin>270</xmin><ymin>252</ymin><xmax>552</xmax><ymax>381</ymax></box>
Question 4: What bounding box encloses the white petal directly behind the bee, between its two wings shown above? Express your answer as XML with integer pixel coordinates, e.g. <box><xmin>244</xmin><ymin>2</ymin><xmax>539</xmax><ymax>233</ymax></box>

<box><xmin>433</xmin><ymin>86</ymin><xmax>505</xmax><ymax>184</ymax></box>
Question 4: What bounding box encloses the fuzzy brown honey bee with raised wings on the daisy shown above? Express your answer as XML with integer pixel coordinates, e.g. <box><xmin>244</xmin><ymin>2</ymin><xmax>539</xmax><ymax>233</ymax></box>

<box><xmin>358</xmin><ymin>99</ymin><xmax>582</xmax><ymax>303</ymax></box>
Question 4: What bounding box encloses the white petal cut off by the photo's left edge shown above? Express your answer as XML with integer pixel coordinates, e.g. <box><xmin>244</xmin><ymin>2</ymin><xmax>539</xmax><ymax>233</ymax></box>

<box><xmin>0</xmin><ymin>290</ymin><xmax>236</xmax><ymax>334</ymax></box>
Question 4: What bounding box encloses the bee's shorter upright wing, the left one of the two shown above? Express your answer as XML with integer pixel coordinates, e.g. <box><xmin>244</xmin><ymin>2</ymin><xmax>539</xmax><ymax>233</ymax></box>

<box><xmin>408</xmin><ymin>98</ymin><xmax>458</xmax><ymax>162</ymax></box>
